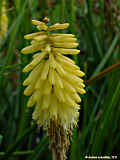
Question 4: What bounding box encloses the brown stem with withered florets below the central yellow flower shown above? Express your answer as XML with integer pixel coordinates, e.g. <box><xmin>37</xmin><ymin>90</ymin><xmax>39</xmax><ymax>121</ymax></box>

<box><xmin>48</xmin><ymin>120</ymin><xmax>70</xmax><ymax>160</ymax></box>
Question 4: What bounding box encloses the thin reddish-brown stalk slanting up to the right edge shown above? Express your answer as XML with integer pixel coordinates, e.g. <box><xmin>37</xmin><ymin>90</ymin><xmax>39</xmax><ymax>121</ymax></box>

<box><xmin>85</xmin><ymin>61</ymin><xmax>120</xmax><ymax>85</ymax></box>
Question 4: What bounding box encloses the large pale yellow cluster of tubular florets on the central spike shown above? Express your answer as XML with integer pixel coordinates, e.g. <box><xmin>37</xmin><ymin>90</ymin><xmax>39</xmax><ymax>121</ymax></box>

<box><xmin>21</xmin><ymin>20</ymin><xmax>85</xmax><ymax>129</ymax></box>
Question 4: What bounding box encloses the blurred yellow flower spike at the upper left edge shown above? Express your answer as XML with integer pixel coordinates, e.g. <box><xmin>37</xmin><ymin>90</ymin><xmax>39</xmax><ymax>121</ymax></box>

<box><xmin>0</xmin><ymin>0</ymin><xmax>8</xmax><ymax>43</ymax></box>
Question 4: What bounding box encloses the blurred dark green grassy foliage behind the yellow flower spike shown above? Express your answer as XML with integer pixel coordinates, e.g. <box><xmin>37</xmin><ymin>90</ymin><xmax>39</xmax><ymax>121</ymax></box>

<box><xmin>0</xmin><ymin>0</ymin><xmax>120</xmax><ymax>160</ymax></box>
